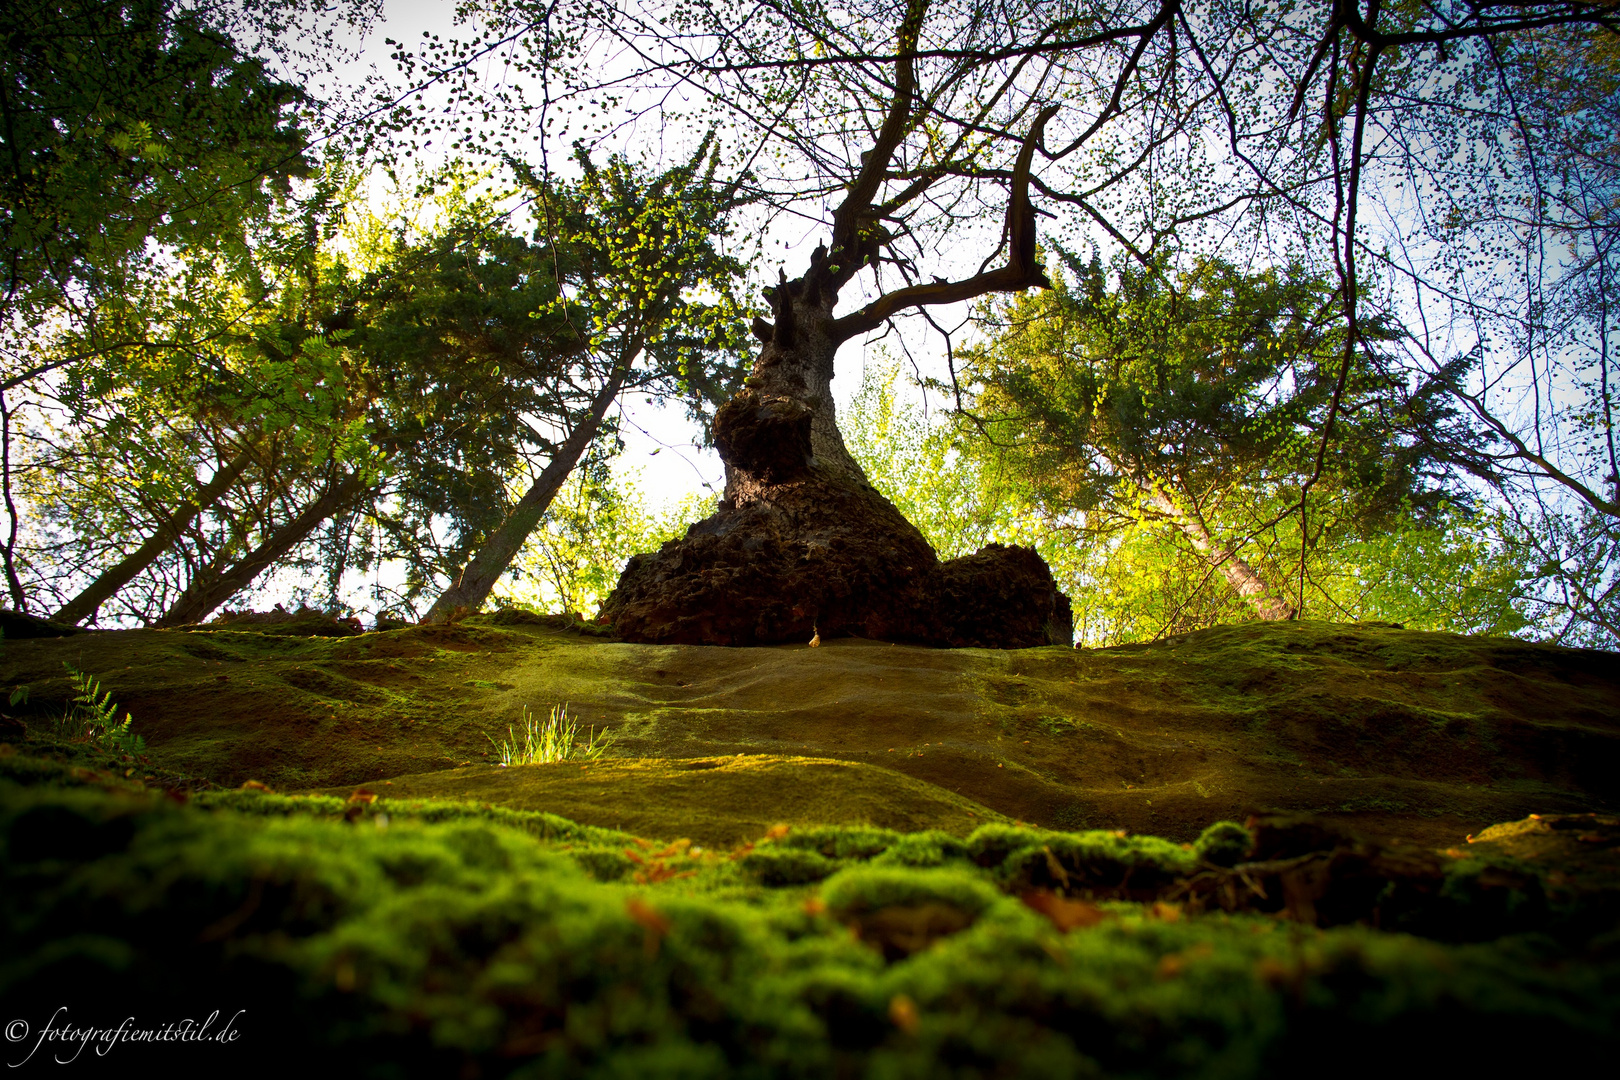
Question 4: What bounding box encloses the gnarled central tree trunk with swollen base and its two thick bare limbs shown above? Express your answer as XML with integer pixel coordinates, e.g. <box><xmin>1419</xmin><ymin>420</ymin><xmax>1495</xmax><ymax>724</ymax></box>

<box><xmin>598</xmin><ymin>52</ymin><xmax>1072</xmax><ymax>648</ymax></box>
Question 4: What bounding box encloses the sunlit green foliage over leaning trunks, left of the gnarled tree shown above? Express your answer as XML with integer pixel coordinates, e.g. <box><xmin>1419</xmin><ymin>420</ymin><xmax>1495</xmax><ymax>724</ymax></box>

<box><xmin>18</xmin><ymin>148</ymin><xmax>737</xmax><ymax>623</ymax></box>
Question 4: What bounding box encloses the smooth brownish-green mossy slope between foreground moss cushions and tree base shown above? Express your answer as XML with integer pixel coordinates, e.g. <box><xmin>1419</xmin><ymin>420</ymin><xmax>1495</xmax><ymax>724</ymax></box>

<box><xmin>0</xmin><ymin>614</ymin><xmax>1620</xmax><ymax>845</ymax></box>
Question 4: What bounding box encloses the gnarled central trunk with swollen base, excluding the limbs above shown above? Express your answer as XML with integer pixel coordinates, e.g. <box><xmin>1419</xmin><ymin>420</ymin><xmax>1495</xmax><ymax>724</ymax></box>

<box><xmin>599</xmin><ymin>251</ymin><xmax>1072</xmax><ymax>648</ymax></box>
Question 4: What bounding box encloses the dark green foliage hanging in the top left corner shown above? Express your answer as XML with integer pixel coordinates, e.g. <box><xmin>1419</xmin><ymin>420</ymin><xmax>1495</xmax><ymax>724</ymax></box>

<box><xmin>0</xmin><ymin>0</ymin><xmax>341</xmax><ymax>621</ymax></box>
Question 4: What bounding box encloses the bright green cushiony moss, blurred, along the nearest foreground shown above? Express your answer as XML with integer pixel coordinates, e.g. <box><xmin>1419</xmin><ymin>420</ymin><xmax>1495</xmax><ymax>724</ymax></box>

<box><xmin>0</xmin><ymin>782</ymin><xmax>1620</xmax><ymax>1077</ymax></box>
